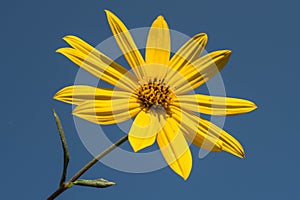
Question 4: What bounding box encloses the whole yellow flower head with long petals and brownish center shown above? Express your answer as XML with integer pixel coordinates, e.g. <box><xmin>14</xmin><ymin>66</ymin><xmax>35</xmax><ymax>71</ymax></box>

<box><xmin>54</xmin><ymin>11</ymin><xmax>256</xmax><ymax>179</ymax></box>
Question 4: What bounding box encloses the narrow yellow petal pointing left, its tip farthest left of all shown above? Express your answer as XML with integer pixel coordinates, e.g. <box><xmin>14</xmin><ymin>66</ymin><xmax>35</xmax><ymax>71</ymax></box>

<box><xmin>53</xmin><ymin>85</ymin><xmax>133</xmax><ymax>105</ymax></box>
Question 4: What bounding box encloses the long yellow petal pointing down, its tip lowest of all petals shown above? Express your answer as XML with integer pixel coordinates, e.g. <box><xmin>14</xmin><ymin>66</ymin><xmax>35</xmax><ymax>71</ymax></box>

<box><xmin>157</xmin><ymin>117</ymin><xmax>192</xmax><ymax>180</ymax></box>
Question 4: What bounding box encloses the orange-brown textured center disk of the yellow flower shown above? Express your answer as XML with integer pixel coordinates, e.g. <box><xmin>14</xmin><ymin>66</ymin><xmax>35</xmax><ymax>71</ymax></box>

<box><xmin>137</xmin><ymin>79</ymin><xmax>174</xmax><ymax>114</ymax></box>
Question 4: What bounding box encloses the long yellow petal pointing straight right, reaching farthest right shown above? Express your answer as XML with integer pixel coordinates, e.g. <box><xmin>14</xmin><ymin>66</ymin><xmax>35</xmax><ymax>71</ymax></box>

<box><xmin>173</xmin><ymin>94</ymin><xmax>257</xmax><ymax>116</ymax></box>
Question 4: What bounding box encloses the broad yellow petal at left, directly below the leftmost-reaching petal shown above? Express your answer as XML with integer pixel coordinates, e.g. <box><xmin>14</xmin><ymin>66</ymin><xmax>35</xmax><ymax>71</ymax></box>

<box><xmin>72</xmin><ymin>97</ymin><xmax>141</xmax><ymax>124</ymax></box>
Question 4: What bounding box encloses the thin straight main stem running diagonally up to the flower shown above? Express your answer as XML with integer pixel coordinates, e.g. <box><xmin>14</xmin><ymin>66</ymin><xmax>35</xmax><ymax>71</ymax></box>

<box><xmin>48</xmin><ymin>135</ymin><xmax>128</xmax><ymax>200</ymax></box>
